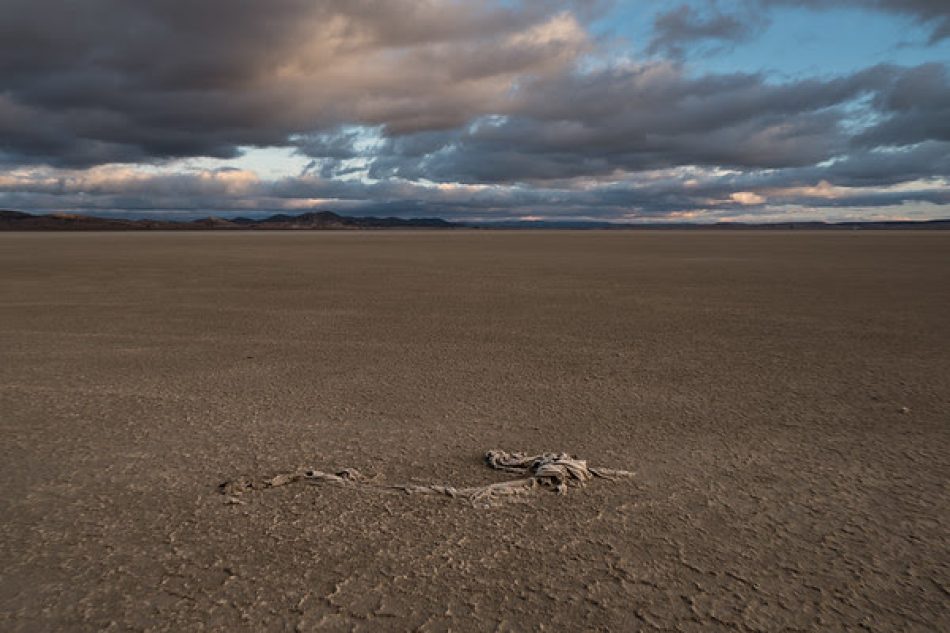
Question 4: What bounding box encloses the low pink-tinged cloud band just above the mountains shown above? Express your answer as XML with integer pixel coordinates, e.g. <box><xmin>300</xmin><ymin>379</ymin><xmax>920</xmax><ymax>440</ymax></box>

<box><xmin>0</xmin><ymin>149</ymin><xmax>950</xmax><ymax>221</ymax></box>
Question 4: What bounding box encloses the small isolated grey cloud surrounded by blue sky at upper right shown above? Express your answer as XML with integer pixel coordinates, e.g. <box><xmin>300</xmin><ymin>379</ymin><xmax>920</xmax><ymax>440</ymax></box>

<box><xmin>647</xmin><ymin>4</ymin><xmax>764</xmax><ymax>57</ymax></box>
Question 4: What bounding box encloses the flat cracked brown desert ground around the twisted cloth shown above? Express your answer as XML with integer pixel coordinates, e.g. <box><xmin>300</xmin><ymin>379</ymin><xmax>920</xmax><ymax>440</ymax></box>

<box><xmin>0</xmin><ymin>232</ymin><xmax>950</xmax><ymax>632</ymax></box>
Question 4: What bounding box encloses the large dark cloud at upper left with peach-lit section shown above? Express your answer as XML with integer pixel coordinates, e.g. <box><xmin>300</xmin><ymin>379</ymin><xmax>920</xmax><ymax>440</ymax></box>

<box><xmin>0</xmin><ymin>0</ymin><xmax>589</xmax><ymax>166</ymax></box>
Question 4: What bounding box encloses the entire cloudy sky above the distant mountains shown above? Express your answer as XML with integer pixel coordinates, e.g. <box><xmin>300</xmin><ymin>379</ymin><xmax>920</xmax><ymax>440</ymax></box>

<box><xmin>0</xmin><ymin>0</ymin><xmax>950</xmax><ymax>223</ymax></box>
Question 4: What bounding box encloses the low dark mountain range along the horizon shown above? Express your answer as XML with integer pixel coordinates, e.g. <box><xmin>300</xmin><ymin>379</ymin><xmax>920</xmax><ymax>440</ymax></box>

<box><xmin>0</xmin><ymin>210</ymin><xmax>950</xmax><ymax>231</ymax></box>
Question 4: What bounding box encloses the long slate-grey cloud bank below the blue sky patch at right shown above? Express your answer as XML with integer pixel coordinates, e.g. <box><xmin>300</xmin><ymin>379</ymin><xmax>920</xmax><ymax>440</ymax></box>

<box><xmin>358</xmin><ymin>63</ymin><xmax>950</xmax><ymax>183</ymax></box>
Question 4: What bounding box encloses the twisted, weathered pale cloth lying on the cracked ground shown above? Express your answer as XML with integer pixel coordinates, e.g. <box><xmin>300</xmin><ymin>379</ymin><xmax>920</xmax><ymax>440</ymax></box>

<box><xmin>219</xmin><ymin>450</ymin><xmax>634</xmax><ymax>505</ymax></box>
